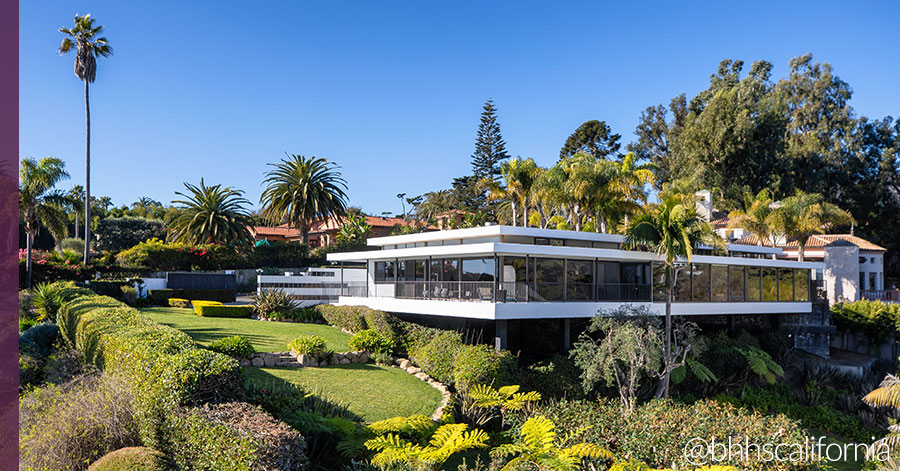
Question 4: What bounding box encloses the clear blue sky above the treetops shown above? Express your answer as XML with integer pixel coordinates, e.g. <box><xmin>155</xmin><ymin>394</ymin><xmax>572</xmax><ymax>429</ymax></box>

<box><xmin>19</xmin><ymin>0</ymin><xmax>900</xmax><ymax>214</ymax></box>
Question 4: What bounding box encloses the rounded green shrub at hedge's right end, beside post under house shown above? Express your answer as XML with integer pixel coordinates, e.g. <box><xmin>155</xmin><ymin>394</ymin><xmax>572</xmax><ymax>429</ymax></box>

<box><xmin>453</xmin><ymin>345</ymin><xmax>518</xmax><ymax>391</ymax></box>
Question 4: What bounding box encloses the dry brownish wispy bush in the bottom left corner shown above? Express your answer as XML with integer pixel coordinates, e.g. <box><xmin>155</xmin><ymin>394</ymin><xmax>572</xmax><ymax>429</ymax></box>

<box><xmin>19</xmin><ymin>375</ymin><xmax>138</xmax><ymax>470</ymax></box>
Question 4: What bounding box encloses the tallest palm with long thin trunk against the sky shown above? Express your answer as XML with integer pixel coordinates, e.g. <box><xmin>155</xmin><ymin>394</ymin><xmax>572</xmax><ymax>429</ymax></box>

<box><xmin>59</xmin><ymin>13</ymin><xmax>112</xmax><ymax>263</ymax></box>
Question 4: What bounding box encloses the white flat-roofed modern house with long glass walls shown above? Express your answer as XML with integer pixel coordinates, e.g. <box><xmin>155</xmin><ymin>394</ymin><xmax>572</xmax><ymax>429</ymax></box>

<box><xmin>328</xmin><ymin>225</ymin><xmax>827</xmax><ymax>354</ymax></box>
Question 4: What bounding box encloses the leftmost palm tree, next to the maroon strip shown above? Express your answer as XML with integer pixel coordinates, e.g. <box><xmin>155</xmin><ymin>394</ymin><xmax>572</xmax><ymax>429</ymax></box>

<box><xmin>19</xmin><ymin>157</ymin><xmax>69</xmax><ymax>288</ymax></box>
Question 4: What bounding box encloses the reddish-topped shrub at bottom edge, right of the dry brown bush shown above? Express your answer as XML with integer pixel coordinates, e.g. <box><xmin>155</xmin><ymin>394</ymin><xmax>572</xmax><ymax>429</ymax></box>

<box><xmin>157</xmin><ymin>402</ymin><xmax>307</xmax><ymax>471</ymax></box>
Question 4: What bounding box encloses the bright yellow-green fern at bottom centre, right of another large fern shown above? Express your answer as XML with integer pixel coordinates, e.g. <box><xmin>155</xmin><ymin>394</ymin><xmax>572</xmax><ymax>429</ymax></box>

<box><xmin>491</xmin><ymin>416</ymin><xmax>614</xmax><ymax>471</ymax></box>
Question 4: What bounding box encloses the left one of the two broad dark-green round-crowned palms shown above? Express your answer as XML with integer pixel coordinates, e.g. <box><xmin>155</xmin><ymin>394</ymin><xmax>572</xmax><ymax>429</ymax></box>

<box><xmin>168</xmin><ymin>179</ymin><xmax>253</xmax><ymax>246</ymax></box>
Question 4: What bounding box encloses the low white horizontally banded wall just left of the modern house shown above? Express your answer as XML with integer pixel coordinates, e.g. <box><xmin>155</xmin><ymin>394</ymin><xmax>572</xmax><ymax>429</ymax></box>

<box><xmin>256</xmin><ymin>268</ymin><xmax>366</xmax><ymax>307</ymax></box>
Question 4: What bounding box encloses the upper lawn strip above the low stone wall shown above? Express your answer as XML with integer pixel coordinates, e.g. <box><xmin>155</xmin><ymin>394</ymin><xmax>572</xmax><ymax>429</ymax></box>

<box><xmin>141</xmin><ymin>307</ymin><xmax>350</xmax><ymax>352</ymax></box>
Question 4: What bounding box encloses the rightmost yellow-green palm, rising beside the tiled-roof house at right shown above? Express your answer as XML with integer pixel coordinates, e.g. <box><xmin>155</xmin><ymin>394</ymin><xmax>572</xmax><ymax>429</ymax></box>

<box><xmin>769</xmin><ymin>190</ymin><xmax>855</xmax><ymax>262</ymax></box>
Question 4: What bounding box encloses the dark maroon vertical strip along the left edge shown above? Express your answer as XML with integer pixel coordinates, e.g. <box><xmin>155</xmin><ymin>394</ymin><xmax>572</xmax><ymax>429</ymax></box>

<box><xmin>0</xmin><ymin>0</ymin><xmax>19</xmax><ymax>470</ymax></box>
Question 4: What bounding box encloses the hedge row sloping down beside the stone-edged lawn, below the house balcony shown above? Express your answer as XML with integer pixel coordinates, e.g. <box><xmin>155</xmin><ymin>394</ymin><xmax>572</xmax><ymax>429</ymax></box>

<box><xmin>316</xmin><ymin>304</ymin><xmax>518</xmax><ymax>390</ymax></box>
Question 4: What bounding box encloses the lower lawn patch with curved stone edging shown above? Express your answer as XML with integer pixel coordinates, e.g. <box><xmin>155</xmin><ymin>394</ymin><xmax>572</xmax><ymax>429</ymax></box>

<box><xmin>244</xmin><ymin>363</ymin><xmax>441</xmax><ymax>422</ymax></box>
